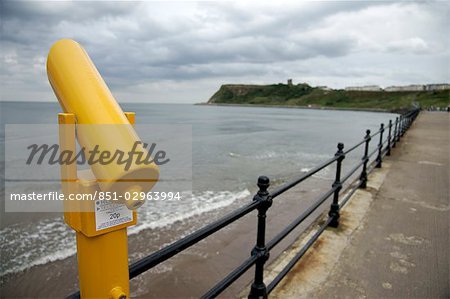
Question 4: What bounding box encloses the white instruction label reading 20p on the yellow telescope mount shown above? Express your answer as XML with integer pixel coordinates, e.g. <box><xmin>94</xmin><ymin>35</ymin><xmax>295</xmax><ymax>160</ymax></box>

<box><xmin>95</xmin><ymin>200</ymin><xmax>133</xmax><ymax>231</ymax></box>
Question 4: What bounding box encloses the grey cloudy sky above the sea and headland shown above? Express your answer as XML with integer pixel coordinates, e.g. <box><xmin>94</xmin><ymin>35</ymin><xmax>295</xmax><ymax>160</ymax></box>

<box><xmin>0</xmin><ymin>0</ymin><xmax>450</xmax><ymax>103</ymax></box>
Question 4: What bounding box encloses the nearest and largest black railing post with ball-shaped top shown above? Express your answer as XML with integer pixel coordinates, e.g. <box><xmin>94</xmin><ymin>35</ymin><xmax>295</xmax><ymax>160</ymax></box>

<box><xmin>248</xmin><ymin>176</ymin><xmax>272</xmax><ymax>299</ymax></box>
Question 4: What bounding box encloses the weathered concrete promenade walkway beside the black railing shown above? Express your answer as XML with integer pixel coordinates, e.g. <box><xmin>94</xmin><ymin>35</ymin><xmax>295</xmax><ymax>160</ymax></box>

<box><xmin>268</xmin><ymin>112</ymin><xmax>450</xmax><ymax>298</ymax></box>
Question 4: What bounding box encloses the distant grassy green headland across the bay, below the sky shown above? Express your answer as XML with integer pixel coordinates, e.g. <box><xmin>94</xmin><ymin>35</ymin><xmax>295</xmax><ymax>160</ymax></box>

<box><xmin>208</xmin><ymin>83</ymin><xmax>450</xmax><ymax>111</ymax></box>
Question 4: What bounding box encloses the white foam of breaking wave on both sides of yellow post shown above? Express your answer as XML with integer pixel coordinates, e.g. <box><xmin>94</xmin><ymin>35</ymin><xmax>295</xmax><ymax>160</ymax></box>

<box><xmin>0</xmin><ymin>189</ymin><xmax>250</xmax><ymax>276</ymax></box>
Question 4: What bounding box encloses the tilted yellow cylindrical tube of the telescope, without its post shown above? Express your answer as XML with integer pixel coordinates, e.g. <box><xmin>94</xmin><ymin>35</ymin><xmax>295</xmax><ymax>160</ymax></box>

<box><xmin>47</xmin><ymin>39</ymin><xmax>159</xmax><ymax>208</ymax></box>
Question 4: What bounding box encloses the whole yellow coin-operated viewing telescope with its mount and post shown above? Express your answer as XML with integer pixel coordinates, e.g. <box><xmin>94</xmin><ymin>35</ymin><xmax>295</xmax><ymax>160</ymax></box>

<box><xmin>47</xmin><ymin>39</ymin><xmax>159</xmax><ymax>299</ymax></box>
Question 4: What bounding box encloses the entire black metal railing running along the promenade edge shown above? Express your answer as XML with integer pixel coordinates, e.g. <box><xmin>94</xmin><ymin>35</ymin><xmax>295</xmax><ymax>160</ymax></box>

<box><xmin>68</xmin><ymin>109</ymin><xmax>420</xmax><ymax>298</ymax></box>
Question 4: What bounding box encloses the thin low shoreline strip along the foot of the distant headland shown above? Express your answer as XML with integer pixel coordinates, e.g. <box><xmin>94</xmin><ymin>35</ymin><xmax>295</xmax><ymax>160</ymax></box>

<box><xmin>194</xmin><ymin>103</ymin><xmax>399</xmax><ymax>113</ymax></box>
